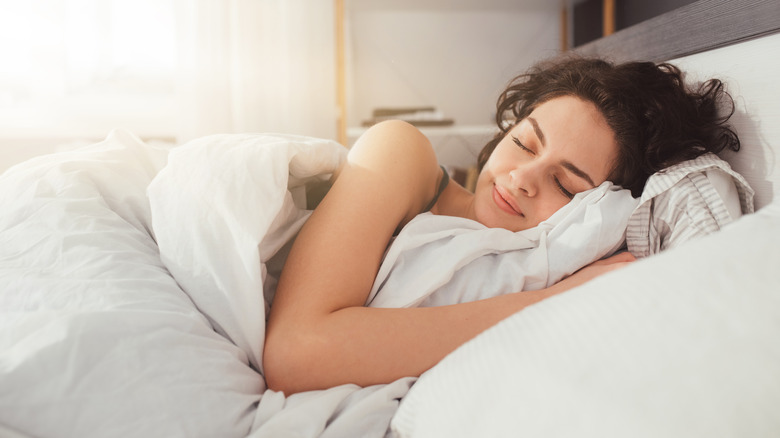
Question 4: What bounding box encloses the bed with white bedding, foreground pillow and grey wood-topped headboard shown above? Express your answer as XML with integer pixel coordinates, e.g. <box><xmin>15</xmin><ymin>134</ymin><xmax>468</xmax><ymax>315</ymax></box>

<box><xmin>0</xmin><ymin>1</ymin><xmax>780</xmax><ymax>437</ymax></box>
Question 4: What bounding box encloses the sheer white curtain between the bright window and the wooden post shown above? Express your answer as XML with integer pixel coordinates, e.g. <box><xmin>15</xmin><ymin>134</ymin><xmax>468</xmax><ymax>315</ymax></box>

<box><xmin>176</xmin><ymin>0</ymin><xmax>337</xmax><ymax>142</ymax></box>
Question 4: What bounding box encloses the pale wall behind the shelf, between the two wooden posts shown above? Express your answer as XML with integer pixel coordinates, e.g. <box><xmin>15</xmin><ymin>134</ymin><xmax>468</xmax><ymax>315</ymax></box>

<box><xmin>346</xmin><ymin>0</ymin><xmax>560</xmax><ymax>127</ymax></box>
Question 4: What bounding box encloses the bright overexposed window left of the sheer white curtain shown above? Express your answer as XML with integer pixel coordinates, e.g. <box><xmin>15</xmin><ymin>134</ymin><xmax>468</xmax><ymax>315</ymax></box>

<box><xmin>0</xmin><ymin>0</ymin><xmax>176</xmax><ymax>138</ymax></box>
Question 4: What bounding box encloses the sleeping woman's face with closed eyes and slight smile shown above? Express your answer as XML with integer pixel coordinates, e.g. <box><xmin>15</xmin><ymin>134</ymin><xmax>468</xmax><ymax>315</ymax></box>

<box><xmin>474</xmin><ymin>96</ymin><xmax>618</xmax><ymax>231</ymax></box>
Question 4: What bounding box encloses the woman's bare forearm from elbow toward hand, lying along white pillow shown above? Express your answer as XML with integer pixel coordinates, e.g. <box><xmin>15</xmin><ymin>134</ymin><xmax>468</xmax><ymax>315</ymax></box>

<box><xmin>264</xmin><ymin>285</ymin><xmax>565</xmax><ymax>394</ymax></box>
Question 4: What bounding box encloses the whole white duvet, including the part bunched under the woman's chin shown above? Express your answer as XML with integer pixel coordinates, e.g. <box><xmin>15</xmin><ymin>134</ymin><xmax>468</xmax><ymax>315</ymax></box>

<box><xmin>0</xmin><ymin>132</ymin><xmax>634</xmax><ymax>437</ymax></box>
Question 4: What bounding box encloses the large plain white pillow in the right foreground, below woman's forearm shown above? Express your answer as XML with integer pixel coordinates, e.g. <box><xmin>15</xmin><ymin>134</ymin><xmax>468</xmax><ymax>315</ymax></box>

<box><xmin>391</xmin><ymin>201</ymin><xmax>780</xmax><ymax>438</ymax></box>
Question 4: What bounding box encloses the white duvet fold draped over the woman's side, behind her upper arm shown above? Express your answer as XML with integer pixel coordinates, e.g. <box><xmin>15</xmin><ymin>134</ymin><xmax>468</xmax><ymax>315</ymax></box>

<box><xmin>148</xmin><ymin>134</ymin><xmax>346</xmax><ymax>371</ymax></box>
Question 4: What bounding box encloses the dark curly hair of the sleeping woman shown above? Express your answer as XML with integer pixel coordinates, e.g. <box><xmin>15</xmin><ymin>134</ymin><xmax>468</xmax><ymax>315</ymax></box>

<box><xmin>478</xmin><ymin>56</ymin><xmax>739</xmax><ymax>197</ymax></box>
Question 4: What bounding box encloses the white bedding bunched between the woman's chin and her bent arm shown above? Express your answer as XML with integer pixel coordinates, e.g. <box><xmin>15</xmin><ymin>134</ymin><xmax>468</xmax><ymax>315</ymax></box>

<box><xmin>367</xmin><ymin>182</ymin><xmax>637</xmax><ymax>307</ymax></box>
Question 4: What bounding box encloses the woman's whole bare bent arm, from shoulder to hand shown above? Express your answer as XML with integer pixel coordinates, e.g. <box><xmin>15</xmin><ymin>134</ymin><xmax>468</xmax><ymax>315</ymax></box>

<box><xmin>263</xmin><ymin>122</ymin><xmax>632</xmax><ymax>394</ymax></box>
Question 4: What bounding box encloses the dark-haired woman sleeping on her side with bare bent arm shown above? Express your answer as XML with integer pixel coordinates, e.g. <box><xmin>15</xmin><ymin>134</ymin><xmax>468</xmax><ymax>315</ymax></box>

<box><xmin>263</xmin><ymin>58</ymin><xmax>739</xmax><ymax>394</ymax></box>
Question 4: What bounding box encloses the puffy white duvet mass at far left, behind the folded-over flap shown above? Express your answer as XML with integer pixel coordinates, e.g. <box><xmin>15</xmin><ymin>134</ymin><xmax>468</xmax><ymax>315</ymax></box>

<box><xmin>0</xmin><ymin>132</ymin><xmax>264</xmax><ymax>437</ymax></box>
